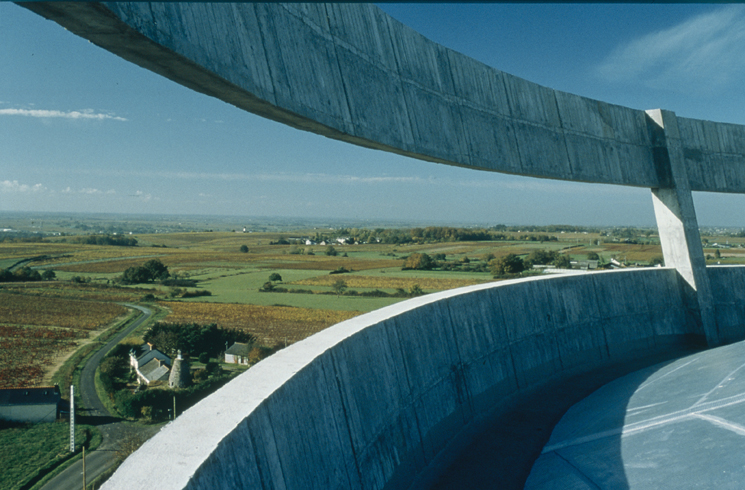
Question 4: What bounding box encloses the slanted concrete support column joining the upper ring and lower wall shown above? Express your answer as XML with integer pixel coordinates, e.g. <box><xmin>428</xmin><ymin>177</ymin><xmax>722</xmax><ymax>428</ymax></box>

<box><xmin>647</xmin><ymin>109</ymin><xmax>720</xmax><ymax>347</ymax></box>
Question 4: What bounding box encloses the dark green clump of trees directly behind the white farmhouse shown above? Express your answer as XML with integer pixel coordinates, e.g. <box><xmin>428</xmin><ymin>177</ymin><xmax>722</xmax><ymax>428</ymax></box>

<box><xmin>143</xmin><ymin>322</ymin><xmax>256</xmax><ymax>357</ymax></box>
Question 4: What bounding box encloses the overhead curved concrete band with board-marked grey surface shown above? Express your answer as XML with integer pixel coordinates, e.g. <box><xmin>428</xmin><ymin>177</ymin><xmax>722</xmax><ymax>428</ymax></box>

<box><xmin>22</xmin><ymin>2</ymin><xmax>745</xmax><ymax>192</ymax></box>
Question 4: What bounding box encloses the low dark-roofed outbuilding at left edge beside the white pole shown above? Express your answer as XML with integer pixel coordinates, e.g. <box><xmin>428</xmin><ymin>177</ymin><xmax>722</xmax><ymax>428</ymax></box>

<box><xmin>0</xmin><ymin>386</ymin><xmax>61</xmax><ymax>423</ymax></box>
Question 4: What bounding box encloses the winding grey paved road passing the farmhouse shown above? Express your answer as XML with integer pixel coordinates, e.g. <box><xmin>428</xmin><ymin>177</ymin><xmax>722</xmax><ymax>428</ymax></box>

<box><xmin>42</xmin><ymin>304</ymin><xmax>159</xmax><ymax>490</ymax></box>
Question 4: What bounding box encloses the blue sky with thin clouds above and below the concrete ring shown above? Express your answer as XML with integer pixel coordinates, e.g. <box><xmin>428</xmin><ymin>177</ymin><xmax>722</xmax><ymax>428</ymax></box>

<box><xmin>0</xmin><ymin>2</ymin><xmax>745</xmax><ymax>226</ymax></box>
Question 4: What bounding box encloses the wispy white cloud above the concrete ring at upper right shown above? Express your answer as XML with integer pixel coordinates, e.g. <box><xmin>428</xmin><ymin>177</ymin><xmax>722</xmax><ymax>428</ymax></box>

<box><xmin>596</xmin><ymin>5</ymin><xmax>745</xmax><ymax>92</ymax></box>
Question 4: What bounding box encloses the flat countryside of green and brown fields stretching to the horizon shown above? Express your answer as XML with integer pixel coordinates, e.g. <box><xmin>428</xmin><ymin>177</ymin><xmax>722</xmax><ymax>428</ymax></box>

<box><xmin>0</xmin><ymin>213</ymin><xmax>745</xmax><ymax>488</ymax></box>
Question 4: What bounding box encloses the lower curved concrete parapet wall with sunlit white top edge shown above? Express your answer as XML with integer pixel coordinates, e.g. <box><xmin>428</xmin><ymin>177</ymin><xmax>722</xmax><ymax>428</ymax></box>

<box><xmin>97</xmin><ymin>268</ymin><xmax>720</xmax><ymax>489</ymax></box>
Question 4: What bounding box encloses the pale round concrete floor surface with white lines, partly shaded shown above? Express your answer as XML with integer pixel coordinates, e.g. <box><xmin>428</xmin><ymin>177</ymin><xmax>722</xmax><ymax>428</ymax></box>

<box><xmin>520</xmin><ymin>336</ymin><xmax>745</xmax><ymax>490</ymax></box>
